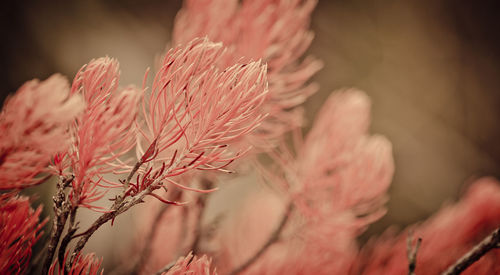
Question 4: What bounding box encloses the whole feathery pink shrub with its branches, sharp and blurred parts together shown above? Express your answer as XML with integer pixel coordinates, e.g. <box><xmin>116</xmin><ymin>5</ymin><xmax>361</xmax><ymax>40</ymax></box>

<box><xmin>0</xmin><ymin>0</ymin><xmax>500</xmax><ymax>275</ymax></box>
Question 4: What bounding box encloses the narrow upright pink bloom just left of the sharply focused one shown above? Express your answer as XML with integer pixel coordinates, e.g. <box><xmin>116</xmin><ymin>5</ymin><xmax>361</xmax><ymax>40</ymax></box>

<box><xmin>68</xmin><ymin>57</ymin><xmax>142</xmax><ymax>208</ymax></box>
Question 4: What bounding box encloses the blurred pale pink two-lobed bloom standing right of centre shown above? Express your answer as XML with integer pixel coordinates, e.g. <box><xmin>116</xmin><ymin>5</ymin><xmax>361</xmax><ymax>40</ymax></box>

<box><xmin>292</xmin><ymin>89</ymin><xmax>394</xmax><ymax>233</ymax></box>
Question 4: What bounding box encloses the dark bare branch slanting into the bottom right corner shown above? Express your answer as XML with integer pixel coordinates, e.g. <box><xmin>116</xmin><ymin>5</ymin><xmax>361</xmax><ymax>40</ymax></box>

<box><xmin>442</xmin><ymin>228</ymin><xmax>500</xmax><ymax>275</ymax></box>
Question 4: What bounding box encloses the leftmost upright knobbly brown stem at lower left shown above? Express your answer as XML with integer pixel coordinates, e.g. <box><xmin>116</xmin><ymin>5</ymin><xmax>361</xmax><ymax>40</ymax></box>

<box><xmin>42</xmin><ymin>176</ymin><xmax>74</xmax><ymax>274</ymax></box>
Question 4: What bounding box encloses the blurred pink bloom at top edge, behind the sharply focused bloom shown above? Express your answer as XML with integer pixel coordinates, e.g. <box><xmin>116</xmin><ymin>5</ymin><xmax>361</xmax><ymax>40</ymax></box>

<box><xmin>173</xmin><ymin>0</ymin><xmax>322</xmax><ymax>145</ymax></box>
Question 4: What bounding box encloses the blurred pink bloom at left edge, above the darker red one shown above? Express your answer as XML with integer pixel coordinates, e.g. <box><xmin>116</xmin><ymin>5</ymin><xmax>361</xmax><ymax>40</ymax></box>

<box><xmin>0</xmin><ymin>75</ymin><xmax>84</xmax><ymax>189</ymax></box>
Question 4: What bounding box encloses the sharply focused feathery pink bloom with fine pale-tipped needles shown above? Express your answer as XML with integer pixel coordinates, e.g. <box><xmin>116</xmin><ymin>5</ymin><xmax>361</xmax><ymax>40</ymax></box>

<box><xmin>136</xmin><ymin>39</ymin><xmax>267</xmax><ymax>198</ymax></box>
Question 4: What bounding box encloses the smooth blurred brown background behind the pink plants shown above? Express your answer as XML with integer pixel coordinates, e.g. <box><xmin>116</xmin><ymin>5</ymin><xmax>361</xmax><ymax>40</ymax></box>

<box><xmin>0</xmin><ymin>0</ymin><xmax>500</xmax><ymax>268</ymax></box>
